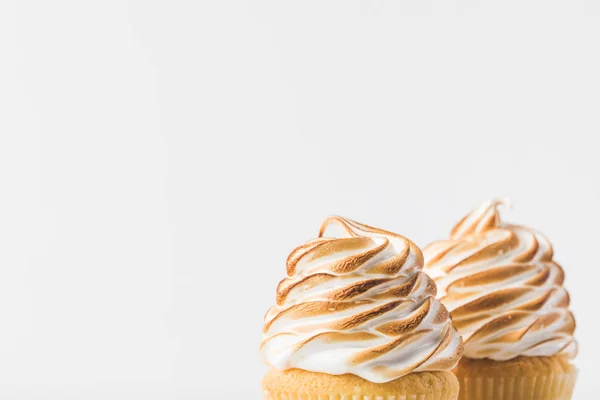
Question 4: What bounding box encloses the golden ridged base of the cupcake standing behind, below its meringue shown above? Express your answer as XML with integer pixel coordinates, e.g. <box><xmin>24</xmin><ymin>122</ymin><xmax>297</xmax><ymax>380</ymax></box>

<box><xmin>454</xmin><ymin>356</ymin><xmax>577</xmax><ymax>400</ymax></box>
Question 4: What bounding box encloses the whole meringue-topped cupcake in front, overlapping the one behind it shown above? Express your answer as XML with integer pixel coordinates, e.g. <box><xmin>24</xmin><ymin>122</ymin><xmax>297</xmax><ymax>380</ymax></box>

<box><xmin>260</xmin><ymin>217</ymin><xmax>462</xmax><ymax>400</ymax></box>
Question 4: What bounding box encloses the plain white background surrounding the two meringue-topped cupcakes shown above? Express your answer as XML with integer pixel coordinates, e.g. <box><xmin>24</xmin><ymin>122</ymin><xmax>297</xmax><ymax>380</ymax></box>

<box><xmin>0</xmin><ymin>0</ymin><xmax>600</xmax><ymax>400</ymax></box>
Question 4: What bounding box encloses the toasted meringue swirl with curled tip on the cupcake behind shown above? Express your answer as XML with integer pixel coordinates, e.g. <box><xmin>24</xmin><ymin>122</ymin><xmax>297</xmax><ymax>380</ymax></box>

<box><xmin>424</xmin><ymin>201</ymin><xmax>577</xmax><ymax>361</ymax></box>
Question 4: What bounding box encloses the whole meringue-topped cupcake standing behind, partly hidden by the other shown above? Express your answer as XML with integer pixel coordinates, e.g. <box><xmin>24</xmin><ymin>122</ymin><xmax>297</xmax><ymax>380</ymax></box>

<box><xmin>424</xmin><ymin>201</ymin><xmax>577</xmax><ymax>400</ymax></box>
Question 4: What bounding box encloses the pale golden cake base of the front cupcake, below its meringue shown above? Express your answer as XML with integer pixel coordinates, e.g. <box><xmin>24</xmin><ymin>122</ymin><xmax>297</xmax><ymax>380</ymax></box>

<box><xmin>262</xmin><ymin>369</ymin><xmax>459</xmax><ymax>400</ymax></box>
